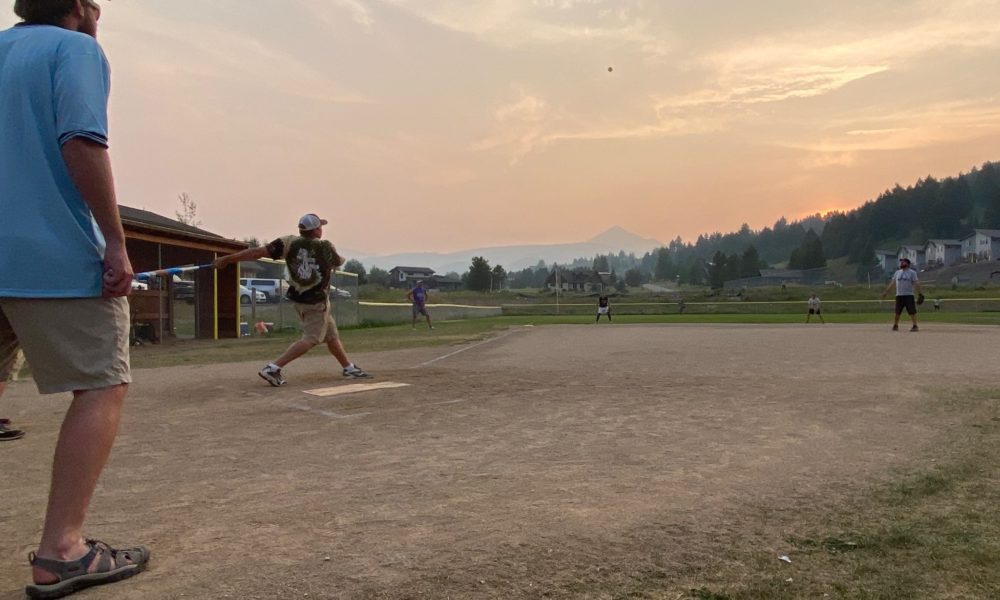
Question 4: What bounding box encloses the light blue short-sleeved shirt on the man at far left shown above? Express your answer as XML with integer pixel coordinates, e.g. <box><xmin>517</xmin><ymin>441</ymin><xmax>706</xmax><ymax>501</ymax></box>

<box><xmin>0</xmin><ymin>25</ymin><xmax>111</xmax><ymax>298</ymax></box>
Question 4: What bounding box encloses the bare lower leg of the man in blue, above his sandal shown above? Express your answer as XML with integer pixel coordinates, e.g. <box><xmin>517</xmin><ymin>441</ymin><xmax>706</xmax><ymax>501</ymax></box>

<box><xmin>32</xmin><ymin>384</ymin><xmax>128</xmax><ymax>583</ymax></box>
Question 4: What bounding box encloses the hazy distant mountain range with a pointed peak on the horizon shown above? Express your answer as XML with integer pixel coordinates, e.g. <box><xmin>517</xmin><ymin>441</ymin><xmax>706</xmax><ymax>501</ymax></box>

<box><xmin>350</xmin><ymin>225</ymin><xmax>663</xmax><ymax>274</ymax></box>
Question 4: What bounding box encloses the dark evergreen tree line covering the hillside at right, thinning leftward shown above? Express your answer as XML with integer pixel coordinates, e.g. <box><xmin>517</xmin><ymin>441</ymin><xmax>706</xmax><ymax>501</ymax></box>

<box><xmin>348</xmin><ymin>163</ymin><xmax>1000</xmax><ymax>291</ymax></box>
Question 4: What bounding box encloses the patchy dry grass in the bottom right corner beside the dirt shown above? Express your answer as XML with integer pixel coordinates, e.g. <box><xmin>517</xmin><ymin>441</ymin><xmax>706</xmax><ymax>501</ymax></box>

<box><xmin>688</xmin><ymin>388</ymin><xmax>1000</xmax><ymax>600</ymax></box>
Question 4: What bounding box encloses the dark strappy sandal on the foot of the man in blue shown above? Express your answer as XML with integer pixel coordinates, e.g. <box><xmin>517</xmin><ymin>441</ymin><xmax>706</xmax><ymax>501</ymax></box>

<box><xmin>24</xmin><ymin>540</ymin><xmax>149</xmax><ymax>599</ymax></box>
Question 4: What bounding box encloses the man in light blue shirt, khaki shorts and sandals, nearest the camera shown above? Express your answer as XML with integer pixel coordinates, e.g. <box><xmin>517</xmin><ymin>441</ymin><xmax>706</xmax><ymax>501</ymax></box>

<box><xmin>0</xmin><ymin>0</ymin><xmax>149</xmax><ymax>598</ymax></box>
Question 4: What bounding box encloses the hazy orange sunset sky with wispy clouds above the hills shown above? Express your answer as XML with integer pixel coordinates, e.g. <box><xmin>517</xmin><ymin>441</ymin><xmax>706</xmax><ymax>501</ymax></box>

<box><xmin>0</xmin><ymin>0</ymin><xmax>1000</xmax><ymax>253</ymax></box>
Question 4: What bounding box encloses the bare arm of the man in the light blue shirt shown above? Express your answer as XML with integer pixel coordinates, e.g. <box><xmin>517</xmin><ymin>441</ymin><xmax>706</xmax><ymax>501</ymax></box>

<box><xmin>62</xmin><ymin>137</ymin><xmax>135</xmax><ymax>297</ymax></box>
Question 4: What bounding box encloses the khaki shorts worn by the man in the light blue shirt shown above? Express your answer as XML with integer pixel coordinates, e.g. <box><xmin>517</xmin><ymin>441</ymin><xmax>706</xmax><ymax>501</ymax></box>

<box><xmin>0</xmin><ymin>298</ymin><xmax>132</xmax><ymax>394</ymax></box>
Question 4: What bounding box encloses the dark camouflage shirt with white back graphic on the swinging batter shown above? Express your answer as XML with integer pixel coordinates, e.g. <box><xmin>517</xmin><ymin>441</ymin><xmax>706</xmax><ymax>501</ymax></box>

<box><xmin>266</xmin><ymin>235</ymin><xmax>344</xmax><ymax>304</ymax></box>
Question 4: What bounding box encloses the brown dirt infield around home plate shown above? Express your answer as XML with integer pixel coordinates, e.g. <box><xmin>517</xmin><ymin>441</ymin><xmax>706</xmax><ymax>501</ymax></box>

<box><xmin>0</xmin><ymin>323</ymin><xmax>997</xmax><ymax>599</ymax></box>
